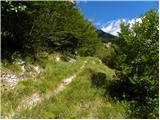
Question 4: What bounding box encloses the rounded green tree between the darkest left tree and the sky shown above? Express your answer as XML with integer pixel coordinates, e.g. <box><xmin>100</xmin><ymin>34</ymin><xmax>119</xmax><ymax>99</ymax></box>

<box><xmin>27</xmin><ymin>1</ymin><xmax>98</xmax><ymax>55</ymax></box>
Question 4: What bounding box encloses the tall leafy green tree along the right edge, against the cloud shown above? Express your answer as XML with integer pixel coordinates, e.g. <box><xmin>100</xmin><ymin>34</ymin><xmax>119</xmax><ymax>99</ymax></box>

<box><xmin>111</xmin><ymin>10</ymin><xmax>159</xmax><ymax>118</ymax></box>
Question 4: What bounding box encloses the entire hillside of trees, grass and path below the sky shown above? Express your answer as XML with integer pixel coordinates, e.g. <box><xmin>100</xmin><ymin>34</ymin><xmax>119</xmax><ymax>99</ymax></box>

<box><xmin>1</xmin><ymin>1</ymin><xmax>159</xmax><ymax>119</ymax></box>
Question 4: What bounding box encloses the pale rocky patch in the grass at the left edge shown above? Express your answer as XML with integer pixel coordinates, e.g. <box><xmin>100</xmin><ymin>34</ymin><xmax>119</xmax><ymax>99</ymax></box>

<box><xmin>1</xmin><ymin>59</ymin><xmax>42</xmax><ymax>89</ymax></box>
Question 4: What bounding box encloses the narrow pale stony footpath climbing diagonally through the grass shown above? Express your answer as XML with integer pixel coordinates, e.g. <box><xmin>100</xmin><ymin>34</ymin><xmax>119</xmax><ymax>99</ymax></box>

<box><xmin>4</xmin><ymin>61</ymin><xmax>87</xmax><ymax>118</ymax></box>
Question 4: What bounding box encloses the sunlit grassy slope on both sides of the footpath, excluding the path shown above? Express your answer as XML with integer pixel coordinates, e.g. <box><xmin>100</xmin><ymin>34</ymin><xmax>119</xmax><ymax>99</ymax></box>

<box><xmin>2</xmin><ymin>54</ymin><xmax>127</xmax><ymax>118</ymax></box>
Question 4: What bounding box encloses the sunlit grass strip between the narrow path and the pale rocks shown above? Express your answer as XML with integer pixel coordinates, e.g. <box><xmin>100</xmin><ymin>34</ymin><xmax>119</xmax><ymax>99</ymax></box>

<box><xmin>1</xmin><ymin>55</ymin><xmax>83</xmax><ymax>116</ymax></box>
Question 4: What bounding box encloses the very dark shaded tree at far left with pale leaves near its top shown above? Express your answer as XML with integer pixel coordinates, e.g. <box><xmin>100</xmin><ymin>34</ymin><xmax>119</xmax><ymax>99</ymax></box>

<box><xmin>1</xmin><ymin>1</ymin><xmax>32</xmax><ymax>59</ymax></box>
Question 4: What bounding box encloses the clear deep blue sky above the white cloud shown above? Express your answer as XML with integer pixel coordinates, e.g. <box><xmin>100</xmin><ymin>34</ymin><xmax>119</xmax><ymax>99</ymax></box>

<box><xmin>77</xmin><ymin>1</ymin><xmax>159</xmax><ymax>35</ymax></box>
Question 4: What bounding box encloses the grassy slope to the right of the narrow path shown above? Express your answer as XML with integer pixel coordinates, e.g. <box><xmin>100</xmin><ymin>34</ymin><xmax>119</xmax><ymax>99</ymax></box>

<box><xmin>14</xmin><ymin>59</ymin><xmax>127</xmax><ymax>119</ymax></box>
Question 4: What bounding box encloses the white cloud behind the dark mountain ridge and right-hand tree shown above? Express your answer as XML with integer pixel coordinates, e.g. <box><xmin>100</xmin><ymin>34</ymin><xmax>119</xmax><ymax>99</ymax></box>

<box><xmin>101</xmin><ymin>18</ymin><xmax>142</xmax><ymax>36</ymax></box>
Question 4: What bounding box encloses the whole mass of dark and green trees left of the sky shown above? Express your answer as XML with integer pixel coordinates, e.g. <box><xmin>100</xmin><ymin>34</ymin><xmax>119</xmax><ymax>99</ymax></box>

<box><xmin>2</xmin><ymin>1</ymin><xmax>100</xmax><ymax>58</ymax></box>
